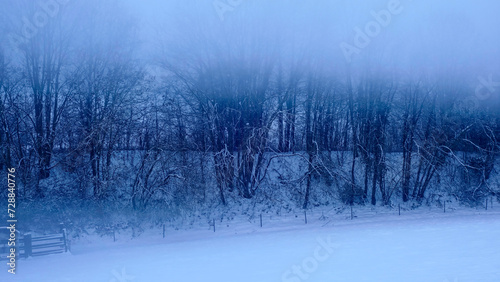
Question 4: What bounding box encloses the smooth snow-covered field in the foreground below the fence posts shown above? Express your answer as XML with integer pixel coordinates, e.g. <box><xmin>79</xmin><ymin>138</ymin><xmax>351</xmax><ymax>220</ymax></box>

<box><xmin>0</xmin><ymin>206</ymin><xmax>500</xmax><ymax>282</ymax></box>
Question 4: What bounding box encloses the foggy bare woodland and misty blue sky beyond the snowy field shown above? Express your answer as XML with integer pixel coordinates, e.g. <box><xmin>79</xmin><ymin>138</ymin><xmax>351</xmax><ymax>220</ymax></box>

<box><xmin>0</xmin><ymin>0</ymin><xmax>500</xmax><ymax>234</ymax></box>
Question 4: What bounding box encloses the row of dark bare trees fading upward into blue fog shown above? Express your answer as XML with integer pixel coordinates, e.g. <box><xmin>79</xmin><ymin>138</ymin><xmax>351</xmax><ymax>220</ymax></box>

<box><xmin>0</xmin><ymin>1</ymin><xmax>500</xmax><ymax>208</ymax></box>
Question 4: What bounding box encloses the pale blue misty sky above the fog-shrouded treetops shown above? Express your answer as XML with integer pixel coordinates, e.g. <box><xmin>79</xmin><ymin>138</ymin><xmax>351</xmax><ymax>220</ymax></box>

<box><xmin>1</xmin><ymin>0</ymin><xmax>500</xmax><ymax>81</ymax></box>
